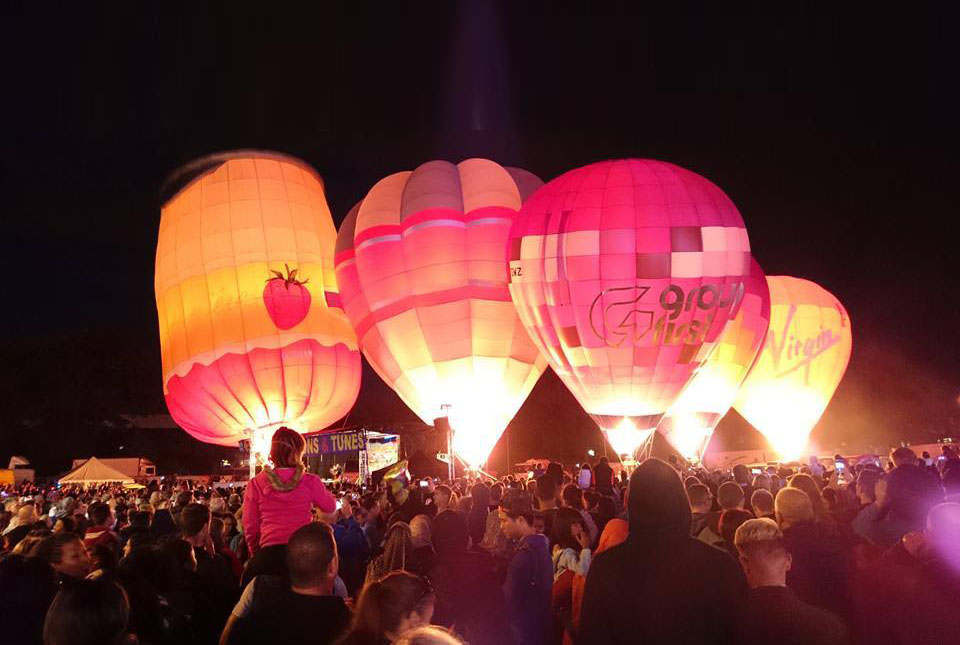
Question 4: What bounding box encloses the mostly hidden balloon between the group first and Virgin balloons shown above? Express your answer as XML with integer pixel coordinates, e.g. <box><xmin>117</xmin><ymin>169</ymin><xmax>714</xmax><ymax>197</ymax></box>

<box><xmin>658</xmin><ymin>254</ymin><xmax>770</xmax><ymax>462</ymax></box>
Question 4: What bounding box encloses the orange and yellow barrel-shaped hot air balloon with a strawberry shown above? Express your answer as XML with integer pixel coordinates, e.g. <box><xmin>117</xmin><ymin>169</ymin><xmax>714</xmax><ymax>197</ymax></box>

<box><xmin>155</xmin><ymin>151</ymin><xmax>360</xmax><ymax>462</ymax></box>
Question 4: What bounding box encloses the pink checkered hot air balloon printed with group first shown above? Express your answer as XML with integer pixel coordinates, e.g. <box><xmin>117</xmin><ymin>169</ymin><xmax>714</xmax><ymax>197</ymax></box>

<box><xmin>510</xmin><ymin>159</ymin><xmax>750</xmax><ymax>453</ymax></box>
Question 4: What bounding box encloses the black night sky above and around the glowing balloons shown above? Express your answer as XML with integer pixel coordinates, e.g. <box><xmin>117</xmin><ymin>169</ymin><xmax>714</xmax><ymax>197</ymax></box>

<box><xmin>0</xmin><ymin>0</ymin><xmax>960</xmax><ymax>467</ymax></box>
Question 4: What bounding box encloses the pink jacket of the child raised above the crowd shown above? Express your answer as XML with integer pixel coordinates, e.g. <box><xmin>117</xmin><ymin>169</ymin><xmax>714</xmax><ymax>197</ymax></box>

<box><xmin>243</xmin><ymin>468</ymin><xmax>336</xmax><ymax>553</ymax></box>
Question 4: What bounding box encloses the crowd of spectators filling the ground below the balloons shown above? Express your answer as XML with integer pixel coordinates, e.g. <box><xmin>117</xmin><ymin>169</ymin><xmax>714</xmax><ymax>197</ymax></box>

<box><xmin>0</xmin><ymin>428</ymin><xmax>960</xmax><ymax>645</ymax></box>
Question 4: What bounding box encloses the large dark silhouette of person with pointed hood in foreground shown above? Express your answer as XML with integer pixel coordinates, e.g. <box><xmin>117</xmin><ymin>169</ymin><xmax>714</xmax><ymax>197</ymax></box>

<box><xmin>576</xmin><ymin>459</ymin><xmax>747</xmax><ymax>644</ymax></box>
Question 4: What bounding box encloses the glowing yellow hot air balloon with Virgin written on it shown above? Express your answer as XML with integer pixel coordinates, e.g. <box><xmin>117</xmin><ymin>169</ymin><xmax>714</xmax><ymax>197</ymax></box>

<box><xmin>734</xmin><ymin>276</ymin><xmax>853</xmax><ymax>459</ymax></box>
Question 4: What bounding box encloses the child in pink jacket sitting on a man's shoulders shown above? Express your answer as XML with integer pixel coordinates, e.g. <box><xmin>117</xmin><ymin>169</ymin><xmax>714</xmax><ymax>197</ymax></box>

<box><xmin>241</xmin><ymin>428</ymin><xmax>336</xmax><ymax>586</ymax></box>
